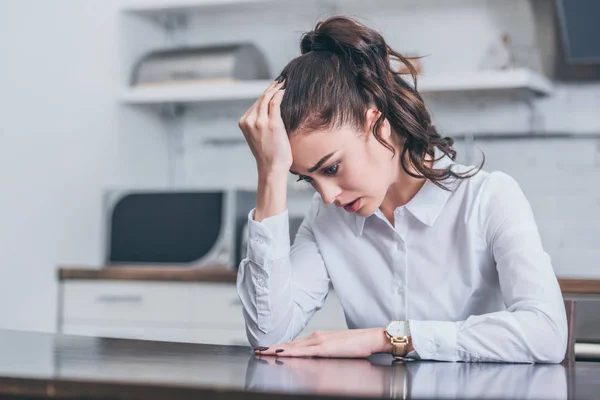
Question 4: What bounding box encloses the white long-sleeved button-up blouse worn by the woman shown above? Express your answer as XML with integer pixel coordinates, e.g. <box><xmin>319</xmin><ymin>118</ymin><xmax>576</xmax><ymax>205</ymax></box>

<box><xmin>237</xmin><ymin>151</ymin><xmax>567</xmax><ymax>362</ymax></box>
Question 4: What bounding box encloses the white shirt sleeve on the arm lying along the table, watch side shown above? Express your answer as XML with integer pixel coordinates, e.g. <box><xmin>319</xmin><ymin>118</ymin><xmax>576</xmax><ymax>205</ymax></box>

<box><xmin>409</xmin><ymin>173</ymin><xmax>567</xmax><ymax>363</ymax></box>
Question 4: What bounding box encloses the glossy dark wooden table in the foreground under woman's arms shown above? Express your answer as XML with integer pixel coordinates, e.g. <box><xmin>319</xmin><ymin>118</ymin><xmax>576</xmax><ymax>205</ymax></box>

<box><xmin>0</xmin><ymin>331</ymin><xmax>600</xmax><ymax>399</ymax></box>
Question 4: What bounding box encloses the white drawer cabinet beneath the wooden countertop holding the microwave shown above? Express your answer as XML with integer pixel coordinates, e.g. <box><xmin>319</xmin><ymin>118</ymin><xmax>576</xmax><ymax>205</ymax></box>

<box><xmin>59</xmin><ymin>280</ymin><xmax>346</xmax><ymax>346</ymax></box>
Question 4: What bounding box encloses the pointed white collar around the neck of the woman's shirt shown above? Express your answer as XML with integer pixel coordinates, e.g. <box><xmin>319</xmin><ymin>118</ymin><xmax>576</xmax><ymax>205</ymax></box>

<box><xmin>354</xmin><ymin>148</ymin><xmax>456</xmax><ymax>236</ymax></box>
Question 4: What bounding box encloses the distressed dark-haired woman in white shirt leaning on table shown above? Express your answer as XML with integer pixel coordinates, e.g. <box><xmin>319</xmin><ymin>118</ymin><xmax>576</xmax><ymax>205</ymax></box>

<box><xmin>237</xmin><ymin>17</ymin><xmax>567</xmax><ymax>363</ymax></box>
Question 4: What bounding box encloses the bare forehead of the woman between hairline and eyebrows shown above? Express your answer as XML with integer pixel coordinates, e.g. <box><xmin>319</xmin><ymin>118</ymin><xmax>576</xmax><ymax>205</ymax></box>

<box><xmin>290</xmin><ymin>128</ymin><xmax>361</xmax><ymax>173</ymax></box>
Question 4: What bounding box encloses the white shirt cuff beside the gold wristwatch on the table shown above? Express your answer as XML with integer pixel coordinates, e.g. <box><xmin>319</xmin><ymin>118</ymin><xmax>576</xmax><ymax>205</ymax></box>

<box><xmin>408</xmin><ymin>320</ymin><xmax>459</xmax><ymax>361</ymax></box>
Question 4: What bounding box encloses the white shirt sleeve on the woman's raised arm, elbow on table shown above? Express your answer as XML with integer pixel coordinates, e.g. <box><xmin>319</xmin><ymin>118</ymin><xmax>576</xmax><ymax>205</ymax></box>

<box><xmin>237</xmin><ymin>196</ymin><xmax>330</xmax><ymax>347</ymax></box>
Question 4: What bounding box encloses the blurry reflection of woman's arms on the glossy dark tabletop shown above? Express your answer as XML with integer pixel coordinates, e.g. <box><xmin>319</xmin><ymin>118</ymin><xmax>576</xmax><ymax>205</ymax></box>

<box><xmin>246</xmin><ymin>355</ymin><xmax>572</xmax><ymax>399</ymax></box>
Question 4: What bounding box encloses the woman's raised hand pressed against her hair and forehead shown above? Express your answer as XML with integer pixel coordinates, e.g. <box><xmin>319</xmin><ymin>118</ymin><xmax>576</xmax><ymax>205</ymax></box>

<box><xmin>238</xmin><ymin>80</ymin><xmax>292</xmax><ymax>176</ymax></box>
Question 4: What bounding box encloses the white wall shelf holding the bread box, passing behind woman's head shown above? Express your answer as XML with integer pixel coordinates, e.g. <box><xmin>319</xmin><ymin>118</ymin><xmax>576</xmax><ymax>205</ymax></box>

<box><xmin>120</xmin><ymin>69</ymin><xmax>552</xmax><ymax>105</ymax></box>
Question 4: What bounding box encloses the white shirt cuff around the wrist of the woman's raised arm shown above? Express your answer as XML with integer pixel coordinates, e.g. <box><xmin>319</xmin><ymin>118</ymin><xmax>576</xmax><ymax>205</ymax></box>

<box><xmin>247</xmin><ymin>209</ymin><xmax>290</xmax><ymax>267</ymax></box>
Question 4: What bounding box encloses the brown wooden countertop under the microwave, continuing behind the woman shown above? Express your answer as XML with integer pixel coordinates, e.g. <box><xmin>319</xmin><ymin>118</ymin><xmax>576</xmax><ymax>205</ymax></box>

<box><xmin>58</xmin><ymin>266</ymin><xmax>600</xmax><ymax>294</ymax></box>
